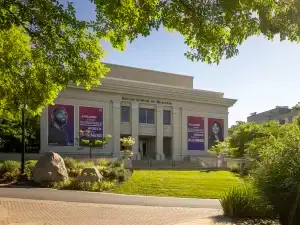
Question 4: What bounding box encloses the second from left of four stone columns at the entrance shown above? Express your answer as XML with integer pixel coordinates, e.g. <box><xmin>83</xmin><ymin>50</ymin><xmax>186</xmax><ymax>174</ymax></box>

<box><xmin>131</xmin><ymin>102</ymin><xmax>141</xmax><ymax>160</ymax></box>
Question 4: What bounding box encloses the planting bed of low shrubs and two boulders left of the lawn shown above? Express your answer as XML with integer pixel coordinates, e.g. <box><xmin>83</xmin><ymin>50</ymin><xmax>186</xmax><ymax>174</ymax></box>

<box><xmin>0</xmin><ymin>156</ymin><xmax>132</xmax><ymax>192</ymax></box>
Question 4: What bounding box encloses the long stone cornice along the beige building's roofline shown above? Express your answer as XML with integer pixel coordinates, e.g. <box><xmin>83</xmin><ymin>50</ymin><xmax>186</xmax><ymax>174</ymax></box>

<box><xmin>69</xmin><ymin>78</ymin><xmax>237</xmax><ymax>107</ymax></box>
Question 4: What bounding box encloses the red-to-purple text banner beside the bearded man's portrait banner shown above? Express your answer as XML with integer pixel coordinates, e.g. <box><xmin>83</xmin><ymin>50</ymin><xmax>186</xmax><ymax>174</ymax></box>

<box><xmin>79</xmin><ymin>106</ymin><xmax>103</xmax><ymax>140</ymax></box>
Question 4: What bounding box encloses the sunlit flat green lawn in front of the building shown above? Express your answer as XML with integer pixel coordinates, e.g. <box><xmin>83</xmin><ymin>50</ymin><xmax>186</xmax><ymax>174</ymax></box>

<box><xmin>112</xmin><ymin>170</ymin><xmax>242</xmax><ymax>198</ymax></box>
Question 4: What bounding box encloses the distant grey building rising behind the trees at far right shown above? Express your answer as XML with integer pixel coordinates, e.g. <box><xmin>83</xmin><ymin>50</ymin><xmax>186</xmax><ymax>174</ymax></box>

<box><xmin>247</xmin><ymin>106</ymin><xmax>300</xmax><ymax>124</ymax></box>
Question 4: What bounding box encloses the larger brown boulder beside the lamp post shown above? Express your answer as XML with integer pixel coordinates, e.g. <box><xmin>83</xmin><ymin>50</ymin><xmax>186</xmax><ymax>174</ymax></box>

<box><xmin>32</xmin><ymin>152</ymin><xmax>68</xmax><ymax>183</ymax></box>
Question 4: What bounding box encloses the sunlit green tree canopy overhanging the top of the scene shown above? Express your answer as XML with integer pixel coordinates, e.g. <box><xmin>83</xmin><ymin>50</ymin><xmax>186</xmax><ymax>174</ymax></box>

<box><xmin>0</xmin><ymin>0</ymin><xmax>300</xmax><ymax>117</ymax></box>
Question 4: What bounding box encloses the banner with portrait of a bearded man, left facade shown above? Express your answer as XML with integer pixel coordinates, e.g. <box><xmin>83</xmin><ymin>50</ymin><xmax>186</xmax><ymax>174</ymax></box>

<box><xmin>48</xmin><ymin>104</ymin><xmax>74</xmax><ymax>146</ymax></box>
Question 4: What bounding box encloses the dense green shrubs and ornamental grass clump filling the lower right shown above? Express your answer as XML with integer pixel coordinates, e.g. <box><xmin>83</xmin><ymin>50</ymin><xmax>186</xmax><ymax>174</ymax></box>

<box><xmin>211</xmin><ymin>117</ymin><xmax>300</xmax><ymax>225</ymax></box>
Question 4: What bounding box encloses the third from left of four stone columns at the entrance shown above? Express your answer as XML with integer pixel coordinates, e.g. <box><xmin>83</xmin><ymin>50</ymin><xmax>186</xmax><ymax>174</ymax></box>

<box><xmin>156</xmin><ymin>105</ymin><xmax>165</xmax><ymax>160</ymax></box>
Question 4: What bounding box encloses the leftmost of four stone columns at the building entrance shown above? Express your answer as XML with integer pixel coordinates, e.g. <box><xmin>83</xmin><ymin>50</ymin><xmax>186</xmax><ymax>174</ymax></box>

<box><xmin>112</xmin><ymin>102</ymin><xmax>121</xmax><ymax>158</ymax></box>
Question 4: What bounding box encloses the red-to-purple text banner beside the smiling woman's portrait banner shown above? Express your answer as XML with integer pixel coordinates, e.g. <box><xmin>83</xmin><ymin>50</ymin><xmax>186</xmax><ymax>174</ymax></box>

<box><xmin>187</xmin><ymin>116</ymin><xmax>205</xmax><ymax>150</ymax></box>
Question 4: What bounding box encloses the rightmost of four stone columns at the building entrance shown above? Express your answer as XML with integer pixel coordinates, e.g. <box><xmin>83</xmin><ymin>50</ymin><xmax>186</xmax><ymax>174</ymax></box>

<box><xmin>172</xmin><ymin>107</ymin><xmax>181</xmax><ymax>160</ymax></box>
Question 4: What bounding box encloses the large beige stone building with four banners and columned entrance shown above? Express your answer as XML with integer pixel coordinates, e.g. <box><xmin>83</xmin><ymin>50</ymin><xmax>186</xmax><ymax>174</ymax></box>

<box><xmin>41</xmin><ymin>64</ymin><xmax>236</xmax><ymax>160</ymax></box>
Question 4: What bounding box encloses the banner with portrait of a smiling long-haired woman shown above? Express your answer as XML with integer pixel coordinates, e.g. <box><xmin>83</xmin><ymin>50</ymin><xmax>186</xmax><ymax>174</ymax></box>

<box><xmin>208</xmin><ymin>118</ymin><xmax>224</xmax><ymax>149</ymax></box>
